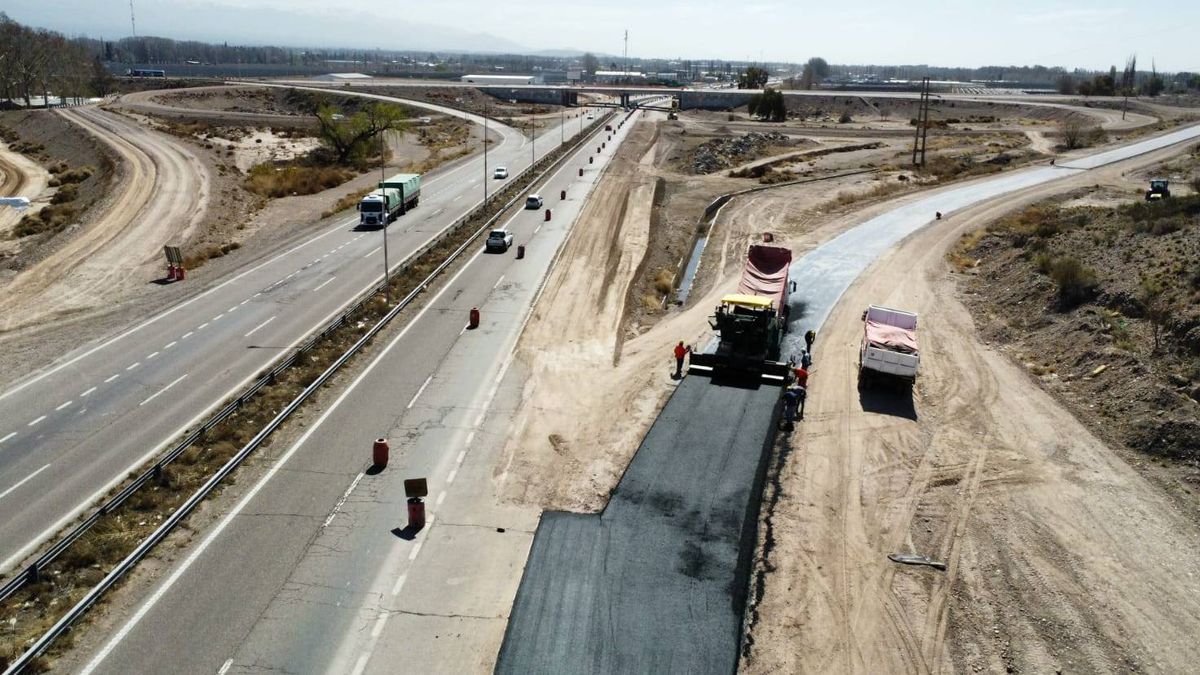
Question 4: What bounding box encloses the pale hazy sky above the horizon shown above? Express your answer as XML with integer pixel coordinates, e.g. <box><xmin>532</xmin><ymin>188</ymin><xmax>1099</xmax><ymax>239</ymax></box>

<box><xmin>9</xmin><ymin>0</ymin><xmax>1200</xmax><ymax>72</ymax></box>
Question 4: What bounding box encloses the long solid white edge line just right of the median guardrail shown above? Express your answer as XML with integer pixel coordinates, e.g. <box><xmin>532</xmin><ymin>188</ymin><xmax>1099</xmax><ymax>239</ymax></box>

<box><xmin>79</xmin><ymin>251</ymin><xmax>484</xmax><ymax>675</ymax></box>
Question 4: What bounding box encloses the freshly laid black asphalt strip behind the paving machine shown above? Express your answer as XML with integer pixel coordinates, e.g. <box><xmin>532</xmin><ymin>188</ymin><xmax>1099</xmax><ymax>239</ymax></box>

<box><xmin>496</xmin><ymin>375</ymin><xmax>781</xmax><ymax>674</ymax></box>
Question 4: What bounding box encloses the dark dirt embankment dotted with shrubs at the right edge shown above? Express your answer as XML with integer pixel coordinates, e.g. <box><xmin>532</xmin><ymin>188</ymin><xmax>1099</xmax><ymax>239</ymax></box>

<box><xmin>955</xmin><ymin>148</ymin><xmax>1200</xmax><ymax>458</ymax></box>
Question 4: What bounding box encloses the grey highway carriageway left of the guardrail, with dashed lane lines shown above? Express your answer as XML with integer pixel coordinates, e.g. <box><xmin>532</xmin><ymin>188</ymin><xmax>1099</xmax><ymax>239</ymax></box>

<box><xmin>0</xmin><ymin>89</ymin><xmax>604</xmax><ymax>571</ymax></box>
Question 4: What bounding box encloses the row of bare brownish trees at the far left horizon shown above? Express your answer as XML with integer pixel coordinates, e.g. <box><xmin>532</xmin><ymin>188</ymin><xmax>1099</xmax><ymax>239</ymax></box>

<box><xmin>0</xmin><ymin>12</ymin><xmax>112</xmax><ymax>107</ymax></box>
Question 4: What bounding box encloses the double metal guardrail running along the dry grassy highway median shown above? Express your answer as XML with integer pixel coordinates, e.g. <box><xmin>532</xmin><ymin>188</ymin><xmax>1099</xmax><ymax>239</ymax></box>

<box><xmin>0</xmin><ymin>107</ymin><xmax>612</xmax><ymax>675</ymax></box>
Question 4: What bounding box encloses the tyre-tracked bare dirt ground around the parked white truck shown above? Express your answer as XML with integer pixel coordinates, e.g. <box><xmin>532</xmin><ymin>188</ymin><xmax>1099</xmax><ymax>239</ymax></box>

<box><xmin>743</xmin><ymin>142</ymin><xmax>1200</xmax><ymax>673</ymax></box>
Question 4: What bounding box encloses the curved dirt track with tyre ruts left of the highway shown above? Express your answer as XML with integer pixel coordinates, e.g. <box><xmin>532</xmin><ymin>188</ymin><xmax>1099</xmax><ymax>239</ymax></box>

<box><xmin>0</xmin><ymin>107</ymin><xmax>211</xmax><ymax>331</ymax></box>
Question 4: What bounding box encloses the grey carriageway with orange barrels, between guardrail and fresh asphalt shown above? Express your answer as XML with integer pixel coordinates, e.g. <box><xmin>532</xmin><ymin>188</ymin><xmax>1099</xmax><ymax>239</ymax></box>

<box><xmin>74</xmin><ymin>107</ymin><xmax>641</xmax><ymax>674</ymax></box>
